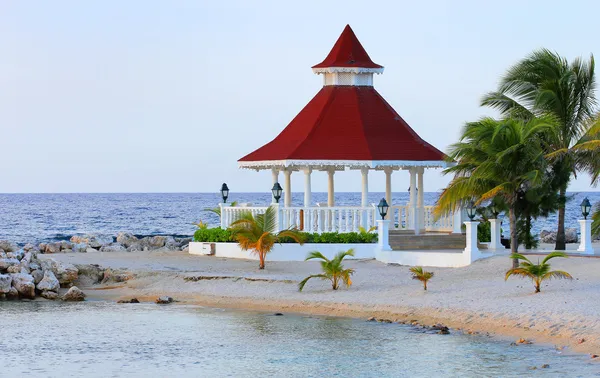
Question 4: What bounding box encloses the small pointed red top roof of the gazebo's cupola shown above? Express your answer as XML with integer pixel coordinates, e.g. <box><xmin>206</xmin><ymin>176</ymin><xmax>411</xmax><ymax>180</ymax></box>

<box><xmin>312</xmin><ymin>25</ymin><xmax>383</xmax><ymax>68</ymax></box>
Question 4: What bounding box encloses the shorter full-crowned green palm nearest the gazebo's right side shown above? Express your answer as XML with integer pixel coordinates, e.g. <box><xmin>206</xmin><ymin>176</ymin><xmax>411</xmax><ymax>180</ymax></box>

<box><xmin>435</xmin><ymin>118</ymin><xmax>552</xmax><ymax>267</ymax></box>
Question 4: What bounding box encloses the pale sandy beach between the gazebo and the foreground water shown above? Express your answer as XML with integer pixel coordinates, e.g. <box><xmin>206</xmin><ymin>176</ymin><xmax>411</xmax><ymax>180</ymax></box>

<box><xmin>46</xmin><ymin>252</ymin><xmax>600</xmax><ymax>354</ymax></box>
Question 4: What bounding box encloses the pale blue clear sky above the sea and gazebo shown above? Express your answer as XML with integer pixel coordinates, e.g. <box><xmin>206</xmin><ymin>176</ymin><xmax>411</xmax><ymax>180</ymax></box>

<box><xmin>0</xmin><ymin>0</ymin><xmax>600</xmax><ymax>193</ymax></box>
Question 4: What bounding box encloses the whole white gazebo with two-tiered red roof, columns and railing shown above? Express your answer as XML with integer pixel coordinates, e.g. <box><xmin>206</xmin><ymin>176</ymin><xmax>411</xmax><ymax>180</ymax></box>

<box><xmin>230</xmin><ymin>25</ymin><xmax>460</xmax><ymax>234</ymax></box>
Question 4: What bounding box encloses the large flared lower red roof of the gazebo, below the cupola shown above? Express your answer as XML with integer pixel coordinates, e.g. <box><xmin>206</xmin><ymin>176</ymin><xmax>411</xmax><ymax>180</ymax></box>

<box><xmin>239</xmin><ymin>86</ymin><xmax>445</xmax><ymax>165</ymax></box>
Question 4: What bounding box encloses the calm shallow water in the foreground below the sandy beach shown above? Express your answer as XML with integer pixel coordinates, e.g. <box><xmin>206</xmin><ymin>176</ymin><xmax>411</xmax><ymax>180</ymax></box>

<box><xmin>0</xmin><ymin>302</ymin><xmax>600</xmax><ymax>377</ymax></box>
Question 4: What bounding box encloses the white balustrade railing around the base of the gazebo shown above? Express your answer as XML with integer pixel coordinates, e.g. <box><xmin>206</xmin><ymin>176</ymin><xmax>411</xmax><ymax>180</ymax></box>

<box><xmin>221</xmin><ymin>205</ymin><xmax>454</xmax><ymax>233</ymax></box>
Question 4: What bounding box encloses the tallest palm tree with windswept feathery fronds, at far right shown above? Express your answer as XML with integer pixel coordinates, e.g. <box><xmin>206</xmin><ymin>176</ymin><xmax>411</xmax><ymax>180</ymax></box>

<box><xmin>482</xmin><ymin>49</ymin><xmax>600</xmax><ymax>250</ymax></box>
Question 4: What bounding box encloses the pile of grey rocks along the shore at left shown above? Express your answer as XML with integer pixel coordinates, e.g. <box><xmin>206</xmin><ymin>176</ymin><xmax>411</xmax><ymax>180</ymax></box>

<box><xmin>0</xmin><ymin>232</ymin><xmax>191</xmax><ymax>301</ymax></box>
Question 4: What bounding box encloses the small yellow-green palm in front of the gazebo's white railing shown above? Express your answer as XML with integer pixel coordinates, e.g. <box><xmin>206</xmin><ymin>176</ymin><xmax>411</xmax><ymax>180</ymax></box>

<box><xmin>229</xmin><ymin>206</ymin><xmax>304</xmax><ymax>269</ymax></box>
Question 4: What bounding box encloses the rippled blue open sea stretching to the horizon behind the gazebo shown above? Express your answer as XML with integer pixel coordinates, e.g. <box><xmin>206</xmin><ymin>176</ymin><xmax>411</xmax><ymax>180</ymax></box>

<box><xmin>0</xmin><ymin>192</ymin><xmax>600</xmax><ymax>243</ymax></box>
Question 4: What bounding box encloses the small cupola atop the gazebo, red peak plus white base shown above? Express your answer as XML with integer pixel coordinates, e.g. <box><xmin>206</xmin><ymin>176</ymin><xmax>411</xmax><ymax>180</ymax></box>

<box><xmin>312</xmin><ymin>25</ymin><xmax>383</xmax><ymax>86</ymax></box>
